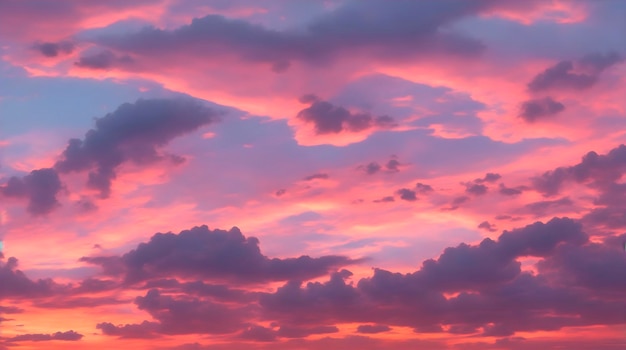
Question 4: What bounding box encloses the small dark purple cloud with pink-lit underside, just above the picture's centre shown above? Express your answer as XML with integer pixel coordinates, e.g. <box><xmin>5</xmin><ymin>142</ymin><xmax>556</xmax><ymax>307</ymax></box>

<box><xmin>297</xmin><ymin>98</ymin><xmax>395</xmax><ymax>135</ymax></box>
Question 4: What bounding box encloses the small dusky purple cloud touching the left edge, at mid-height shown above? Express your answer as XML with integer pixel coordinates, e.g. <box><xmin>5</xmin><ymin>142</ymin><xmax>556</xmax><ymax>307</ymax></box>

<box><xmin>0</xmin><ymin>168</ymin><xmax>63</xmax><ymax>215</ymax></box>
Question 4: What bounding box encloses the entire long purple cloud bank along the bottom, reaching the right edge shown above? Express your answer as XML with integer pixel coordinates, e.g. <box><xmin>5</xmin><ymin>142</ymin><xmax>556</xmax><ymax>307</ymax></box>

<box><xmin>89</xmin><ymin>218</ymin><xmax>626</xmax><ymax>344</ymax></box>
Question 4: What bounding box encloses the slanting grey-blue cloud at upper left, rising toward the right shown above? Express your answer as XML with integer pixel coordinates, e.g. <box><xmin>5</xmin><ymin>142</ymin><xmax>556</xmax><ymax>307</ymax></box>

<box><xmin>54</xmin><ymin>99</ymin><xmax>221</xmax><ymax>198</ymax></box>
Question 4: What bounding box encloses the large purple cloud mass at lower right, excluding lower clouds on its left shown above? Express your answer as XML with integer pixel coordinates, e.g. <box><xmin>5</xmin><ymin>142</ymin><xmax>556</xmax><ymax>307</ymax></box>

<box><xmin>259</xmin><ymin>218</ymin><xmax>626</xmax><ymax>336</ymax></box>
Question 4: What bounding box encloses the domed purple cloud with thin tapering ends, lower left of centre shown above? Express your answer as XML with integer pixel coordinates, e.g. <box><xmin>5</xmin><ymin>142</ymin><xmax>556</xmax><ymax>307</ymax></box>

<box><xmin>81</xmin><ymin>226</ymin><xmax>360</xmax><ymax>283</ymax></box>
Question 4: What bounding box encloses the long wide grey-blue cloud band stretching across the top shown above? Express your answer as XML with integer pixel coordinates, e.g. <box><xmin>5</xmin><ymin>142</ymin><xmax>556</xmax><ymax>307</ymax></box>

<box><xmin>77</xmin><ymin>0</ymin><xmax>512</xmax><ymax>72</ymax></box>
